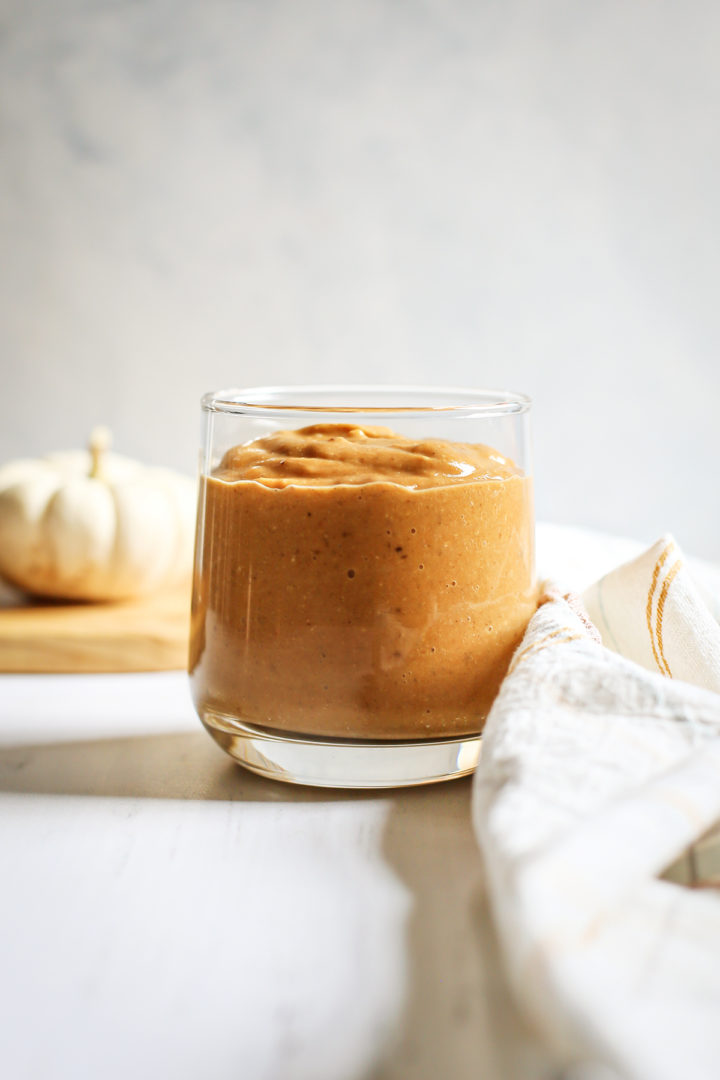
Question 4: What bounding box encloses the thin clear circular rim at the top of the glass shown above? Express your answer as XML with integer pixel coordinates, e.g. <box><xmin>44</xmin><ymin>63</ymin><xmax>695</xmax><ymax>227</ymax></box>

<box><xmin>201</xmin><ymin>383</ymin><xmax>532</xmax><ymax>419</ymax></box>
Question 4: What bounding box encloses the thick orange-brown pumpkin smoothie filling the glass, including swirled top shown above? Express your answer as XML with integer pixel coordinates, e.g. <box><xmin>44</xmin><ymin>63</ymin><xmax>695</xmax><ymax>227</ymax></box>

<box><xmin>190</xmin><ymin>424</ymin><xmax>536</xmax><ymax>741</ymax></box>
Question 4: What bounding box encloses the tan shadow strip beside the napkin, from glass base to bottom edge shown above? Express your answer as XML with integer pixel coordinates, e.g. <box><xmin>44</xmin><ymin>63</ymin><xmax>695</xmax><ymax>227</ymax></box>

<box><xmin>371</xmin><ymin>780</ymin><xmax>554</xmax><ymax>1080</ymax></box>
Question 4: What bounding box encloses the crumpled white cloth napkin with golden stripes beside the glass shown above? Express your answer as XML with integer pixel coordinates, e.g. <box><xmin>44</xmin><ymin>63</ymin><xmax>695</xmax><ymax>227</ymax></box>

<box><xmin>473</xmin><ymin>529</ymin><xmax>720</xmax><ymax>1080</ymax></box>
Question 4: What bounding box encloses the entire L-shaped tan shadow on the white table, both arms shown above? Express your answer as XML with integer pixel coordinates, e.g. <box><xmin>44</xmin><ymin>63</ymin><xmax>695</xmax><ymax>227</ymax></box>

<box><xmin>0</xmin><ymin>730</ymin><xmax>548</xmax><ymax>1080</ymax></box>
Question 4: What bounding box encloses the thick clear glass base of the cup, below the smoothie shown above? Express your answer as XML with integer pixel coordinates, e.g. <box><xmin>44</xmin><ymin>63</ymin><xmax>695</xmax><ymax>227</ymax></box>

<box><xmin>201</xmin><ymin>710</ymin><xmax>480</xmax><ymax>788</ymax></box>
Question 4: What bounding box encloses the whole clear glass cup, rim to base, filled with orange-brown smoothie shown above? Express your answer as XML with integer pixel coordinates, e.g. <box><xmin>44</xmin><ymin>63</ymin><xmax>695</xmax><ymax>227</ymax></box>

<box><xmin>189</xmin><ymin>387</ymin><xmax>536</xmax><ymax>787</ymax></box>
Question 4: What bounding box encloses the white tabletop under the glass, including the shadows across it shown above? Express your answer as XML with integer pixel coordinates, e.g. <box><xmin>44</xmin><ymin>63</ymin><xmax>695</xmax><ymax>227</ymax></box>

<box><xmin>0</xmin><ymin>673</ymin><xmax>546</xmax><ymax>1080</ymax></box>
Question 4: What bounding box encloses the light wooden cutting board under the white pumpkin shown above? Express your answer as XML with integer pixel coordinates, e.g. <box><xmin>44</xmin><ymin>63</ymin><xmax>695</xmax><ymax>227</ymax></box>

<box><xmin>0</xmin><ymin>586</ymin><xmax>190</xmax><ymax>673</ymax></box>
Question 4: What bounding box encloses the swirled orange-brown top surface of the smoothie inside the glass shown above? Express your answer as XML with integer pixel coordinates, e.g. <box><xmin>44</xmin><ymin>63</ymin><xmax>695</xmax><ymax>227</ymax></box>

<box><xmin>213</xmin><ymin>423</ymin><xmax>522</xmax><ymax>488</ymax></box>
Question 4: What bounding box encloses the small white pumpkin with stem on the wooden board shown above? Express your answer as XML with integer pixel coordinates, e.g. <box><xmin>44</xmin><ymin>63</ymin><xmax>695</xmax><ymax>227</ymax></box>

<box><xmin>0</xmin><ymin>429</ymin><xmax>195</xmax><ymax>600</ymax></box>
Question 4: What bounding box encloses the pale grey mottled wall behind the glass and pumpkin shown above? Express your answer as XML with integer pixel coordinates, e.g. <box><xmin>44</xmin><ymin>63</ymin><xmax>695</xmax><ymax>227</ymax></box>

<box><xmin>0</xmin><ymin>0</ymin><xmax>720</xmax><ymax>558</ymax></box>
